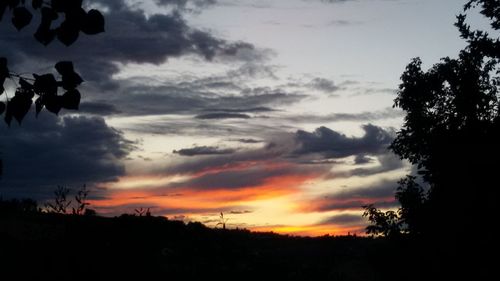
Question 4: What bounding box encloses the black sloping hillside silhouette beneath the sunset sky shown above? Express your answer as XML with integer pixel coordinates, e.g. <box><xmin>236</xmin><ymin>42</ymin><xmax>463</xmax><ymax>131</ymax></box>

<box><xmin>0</xmin><ymin>197</ymin><xmax>426</xmax><ymax>280</ymax></box>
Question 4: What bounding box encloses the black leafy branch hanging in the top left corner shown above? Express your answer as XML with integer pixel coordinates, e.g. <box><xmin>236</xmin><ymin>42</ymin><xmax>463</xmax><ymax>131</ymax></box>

<box><xmin>0</xmin><ymin>0</ymin><xmax>104</xmax><ymax>46</ymax></box>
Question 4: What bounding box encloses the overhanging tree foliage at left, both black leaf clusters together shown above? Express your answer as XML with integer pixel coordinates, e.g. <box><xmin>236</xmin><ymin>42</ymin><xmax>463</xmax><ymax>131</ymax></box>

<box><xmin>0</xmin><ymin>0</ymin><xmax>104</xmax><ymax>175</ymax></box>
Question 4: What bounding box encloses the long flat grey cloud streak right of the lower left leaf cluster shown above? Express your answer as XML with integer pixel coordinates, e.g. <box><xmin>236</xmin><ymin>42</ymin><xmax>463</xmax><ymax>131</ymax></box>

<box><xmin>104</xmin><ymin>83</ymin><xmax>306</xmax><ymax>116</ymax></box>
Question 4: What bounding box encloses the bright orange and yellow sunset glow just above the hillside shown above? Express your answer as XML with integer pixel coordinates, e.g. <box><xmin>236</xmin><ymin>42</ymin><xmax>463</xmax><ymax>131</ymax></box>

<box><xmin>89</xmin><ymin>162</ymin><xmax>370</xmax><ymax>236</ymax></box>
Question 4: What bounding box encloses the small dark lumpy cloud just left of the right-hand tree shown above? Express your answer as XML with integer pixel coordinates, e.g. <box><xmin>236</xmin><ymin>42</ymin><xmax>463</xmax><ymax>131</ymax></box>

<box><xmin>294</xmin><ymin>124</ymin><xmax>394</xmax><ymax>158</ymax></box>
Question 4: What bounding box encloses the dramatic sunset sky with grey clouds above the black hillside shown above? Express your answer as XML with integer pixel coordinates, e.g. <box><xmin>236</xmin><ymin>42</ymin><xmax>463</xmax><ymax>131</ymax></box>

<box><xmin>0</xmin><ymin>0</ymin><xmax>482</xmax><ymax>235</ymax></box>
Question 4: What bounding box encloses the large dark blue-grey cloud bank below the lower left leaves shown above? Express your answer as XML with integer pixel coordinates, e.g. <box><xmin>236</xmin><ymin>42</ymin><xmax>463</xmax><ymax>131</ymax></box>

<box><xmin>0</xmin><ymin>113</ymin><xmax>134</xmax><ymax>199</ymax></box>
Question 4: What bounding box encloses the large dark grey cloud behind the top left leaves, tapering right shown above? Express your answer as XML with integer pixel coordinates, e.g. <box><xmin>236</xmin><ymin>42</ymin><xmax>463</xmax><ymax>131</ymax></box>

<box><xmin>0</xmin><ymin>0</ymin><xmax>260</xmax><ymax>89</ymax></box>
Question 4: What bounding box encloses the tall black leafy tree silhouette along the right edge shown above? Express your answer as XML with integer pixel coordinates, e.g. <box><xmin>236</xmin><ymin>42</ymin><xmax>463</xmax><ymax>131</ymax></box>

<box><xmin>367</xmin><ymin>0</ymin><xmax>500</xmax><ymax>235</ymax></box>
